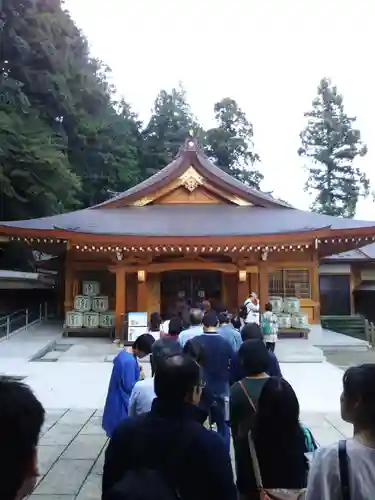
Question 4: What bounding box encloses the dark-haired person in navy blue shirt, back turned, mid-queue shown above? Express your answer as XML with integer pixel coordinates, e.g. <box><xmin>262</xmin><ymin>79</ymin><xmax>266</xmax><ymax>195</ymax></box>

<box><xmin>196</xmin><ymin>311</ymin><xmax>234</xmax><ymax>451</ymax></box>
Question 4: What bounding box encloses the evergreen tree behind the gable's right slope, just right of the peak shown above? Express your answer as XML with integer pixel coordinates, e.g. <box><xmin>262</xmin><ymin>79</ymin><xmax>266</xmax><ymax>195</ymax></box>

<box><xmin>205</xmin><ymin>97</ymin><xmax>263</xmax><ymax>189</ymax></box>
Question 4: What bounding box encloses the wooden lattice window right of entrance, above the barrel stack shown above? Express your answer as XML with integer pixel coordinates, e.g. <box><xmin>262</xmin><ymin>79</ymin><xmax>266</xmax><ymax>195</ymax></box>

<box><xmin>268</xmin><ymin>269</ymin><xmax>310</xmax><ymax>299</ymax></box>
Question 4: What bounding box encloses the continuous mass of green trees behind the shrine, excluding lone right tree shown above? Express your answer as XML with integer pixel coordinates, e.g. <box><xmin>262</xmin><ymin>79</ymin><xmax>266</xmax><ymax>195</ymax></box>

<box><xmin>0</xmin><ymin>0</ymin><xmax>262</xmax><ymax>219</ymax></box>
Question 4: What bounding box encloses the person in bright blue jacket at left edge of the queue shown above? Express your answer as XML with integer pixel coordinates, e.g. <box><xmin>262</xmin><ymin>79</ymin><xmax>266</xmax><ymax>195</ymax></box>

<box><xmin>102</xmin><ymin>333</ymin><xmax>155</xmax><ymax>437</ymax></box>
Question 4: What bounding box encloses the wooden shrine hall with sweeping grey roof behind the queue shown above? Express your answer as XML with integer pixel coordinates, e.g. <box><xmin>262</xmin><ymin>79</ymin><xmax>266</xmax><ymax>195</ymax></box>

<box><xmin>0</xmin><ymin>138</ymin><xmax>375</xmax><ymax>336</ymax></box>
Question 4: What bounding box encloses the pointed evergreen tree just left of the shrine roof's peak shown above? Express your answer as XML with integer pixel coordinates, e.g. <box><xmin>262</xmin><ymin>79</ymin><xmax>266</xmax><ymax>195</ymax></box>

<box><xmin>142</xmin><ymin>85</ymin><xmax>201</xmax><ymax>178</ymax></box>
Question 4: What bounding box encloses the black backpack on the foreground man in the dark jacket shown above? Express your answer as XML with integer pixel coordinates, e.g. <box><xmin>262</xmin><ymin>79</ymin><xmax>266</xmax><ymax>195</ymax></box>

<box><xmin>104</xmin><ymin>429</ymin><xmax>192</xmax><ymax>500</ymax></box>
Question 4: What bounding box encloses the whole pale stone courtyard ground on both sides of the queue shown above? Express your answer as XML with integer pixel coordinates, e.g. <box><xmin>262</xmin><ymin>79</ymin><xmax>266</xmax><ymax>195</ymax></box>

<box><xmin>0</xmin><ymin>325</ymin><xmax>360</xmax><ymax>500</ymax></box>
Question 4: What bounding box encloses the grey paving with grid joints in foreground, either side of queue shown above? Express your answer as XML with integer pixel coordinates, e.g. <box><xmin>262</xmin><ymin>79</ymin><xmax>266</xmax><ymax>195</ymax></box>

<box><xmin>29</xmin><ymin>409</ymin><xmax>352</xmax><ymax>500</ymax></box>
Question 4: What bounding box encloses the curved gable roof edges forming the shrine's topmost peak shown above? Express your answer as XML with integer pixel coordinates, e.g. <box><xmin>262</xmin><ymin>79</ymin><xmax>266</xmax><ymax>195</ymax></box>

<box><xmin>92</xmin><ymin>138</ymin><xmax>291</xmax><ymax>208</ymax></box>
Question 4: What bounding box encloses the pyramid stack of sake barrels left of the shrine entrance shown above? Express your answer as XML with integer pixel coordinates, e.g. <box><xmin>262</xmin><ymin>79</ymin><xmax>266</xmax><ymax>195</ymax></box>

<box><xmin>66</xmin><ymin>281</ymin><xmax>115</xmax><ymax>329</ymax></box>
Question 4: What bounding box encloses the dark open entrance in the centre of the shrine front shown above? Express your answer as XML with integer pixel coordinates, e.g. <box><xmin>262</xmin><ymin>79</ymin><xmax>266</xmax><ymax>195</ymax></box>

<box><xmin>160</xmin><ymin>270</ymin><xmax>222</xmax><ymax>317</ymax></box>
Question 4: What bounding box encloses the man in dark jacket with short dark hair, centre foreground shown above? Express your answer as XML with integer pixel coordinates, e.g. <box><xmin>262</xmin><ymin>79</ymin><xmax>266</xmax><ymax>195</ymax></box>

<box><xmin>102</xmin><ymin>354</ymin><xmax>237</xmax><ymax>500</ymax></box>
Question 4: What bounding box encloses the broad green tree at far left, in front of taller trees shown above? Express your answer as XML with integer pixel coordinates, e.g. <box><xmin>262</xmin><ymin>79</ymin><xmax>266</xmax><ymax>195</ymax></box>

<box><xmin>0</xmin><ymin>63</ymin><xmax>80</xmax><ymax>220</ymax></box>
